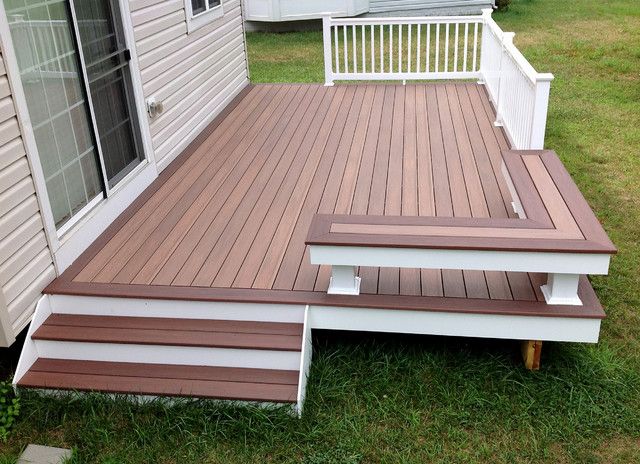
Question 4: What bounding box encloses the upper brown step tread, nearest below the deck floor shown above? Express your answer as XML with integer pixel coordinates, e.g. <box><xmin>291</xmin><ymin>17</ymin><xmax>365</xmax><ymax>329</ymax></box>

<box><xmin>32</xmin><ymin>314</ymin><xmax>303</xmax><ymax>351</ymax></box>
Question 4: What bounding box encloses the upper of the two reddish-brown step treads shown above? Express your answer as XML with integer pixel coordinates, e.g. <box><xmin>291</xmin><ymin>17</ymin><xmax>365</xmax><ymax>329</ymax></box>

<box><xmin>32</xmin><ymin>314</ymin><xmax>302</xmax><ymax>352</ymax></box>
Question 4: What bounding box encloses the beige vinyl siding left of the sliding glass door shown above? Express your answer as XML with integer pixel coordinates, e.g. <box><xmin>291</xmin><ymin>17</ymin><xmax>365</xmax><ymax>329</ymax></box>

<box><xmin>0</xmin><ymin>51</ymin><xmax>55</xmax><ymax>346</ymax></box>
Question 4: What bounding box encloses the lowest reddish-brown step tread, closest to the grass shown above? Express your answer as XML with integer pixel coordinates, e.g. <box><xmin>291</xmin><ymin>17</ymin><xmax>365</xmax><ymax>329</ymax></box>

<box><xmin>18</xmin><ymin>359</ymin><xmax>298</xmax><ymax>403</ymax></box>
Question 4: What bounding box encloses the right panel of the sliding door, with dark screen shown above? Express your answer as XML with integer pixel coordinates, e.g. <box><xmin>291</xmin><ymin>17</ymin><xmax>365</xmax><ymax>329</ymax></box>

<box><xmin>73</xmin><ymin>0</ymin><xmax>143</xmax><ymax>187</ymax></box>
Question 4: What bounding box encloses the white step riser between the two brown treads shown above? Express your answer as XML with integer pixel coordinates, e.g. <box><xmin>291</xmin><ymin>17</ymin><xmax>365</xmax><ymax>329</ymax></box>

<box><xmin>34</xmin><ymin>340</ymin><xmax>301</xmax><ymax>371</ymax></box>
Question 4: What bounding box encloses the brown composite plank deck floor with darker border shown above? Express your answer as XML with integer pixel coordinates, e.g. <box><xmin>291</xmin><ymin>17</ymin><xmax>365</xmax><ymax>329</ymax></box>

<box><xmin>47</xmin><ymin>83</ymin><xmax>602</xmax><ymax>316</ymax></box>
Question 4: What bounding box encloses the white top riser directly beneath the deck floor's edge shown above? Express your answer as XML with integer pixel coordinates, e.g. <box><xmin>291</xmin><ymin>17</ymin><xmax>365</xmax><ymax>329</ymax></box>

<box><xmin>50</xmin><ymin>295</ymin><xmax>305</xmax><ymax>323</ymax></box>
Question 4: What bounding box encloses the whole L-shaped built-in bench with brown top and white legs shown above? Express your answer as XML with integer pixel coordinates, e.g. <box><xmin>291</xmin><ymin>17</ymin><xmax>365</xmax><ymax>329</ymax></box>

<box><xmin>306</xmin><ymin>150</ymin><xmax>616</xmax><ymax>305</ymax></box>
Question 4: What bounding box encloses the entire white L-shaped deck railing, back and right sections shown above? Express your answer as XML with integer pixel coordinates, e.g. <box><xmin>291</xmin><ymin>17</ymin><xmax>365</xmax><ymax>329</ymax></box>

<box><xmin>323</xmin><ymin>9</ymin><xmax>553</xmax><ymax>149</ymax></box>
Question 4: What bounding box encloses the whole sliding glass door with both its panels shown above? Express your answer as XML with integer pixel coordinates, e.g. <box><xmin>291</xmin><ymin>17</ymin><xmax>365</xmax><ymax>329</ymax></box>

<box><xmin>4</xmin><ymin>0</ymin><xmax>143</xmax><ymax>229</ymax></box>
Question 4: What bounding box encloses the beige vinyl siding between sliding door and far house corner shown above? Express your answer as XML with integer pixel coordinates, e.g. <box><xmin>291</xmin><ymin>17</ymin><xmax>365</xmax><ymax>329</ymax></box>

<box><xmin>129</xmin><ymin>0</ymin><xmax>249</xmax><ymax>168</ymax></box>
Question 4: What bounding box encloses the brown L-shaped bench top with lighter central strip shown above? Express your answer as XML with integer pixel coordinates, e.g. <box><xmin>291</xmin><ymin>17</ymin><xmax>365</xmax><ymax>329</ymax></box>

<box><xmin>306</xmin><ymin>150</ymin><xmax>616</xmax><ymax>254</ymax></box>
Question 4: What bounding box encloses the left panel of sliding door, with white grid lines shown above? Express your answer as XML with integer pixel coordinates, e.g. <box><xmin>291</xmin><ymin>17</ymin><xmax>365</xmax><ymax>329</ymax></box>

<box><xmin>4</xmin><ymin>0</ymin><xmax>103</xmax><ymax>228</ymax></box>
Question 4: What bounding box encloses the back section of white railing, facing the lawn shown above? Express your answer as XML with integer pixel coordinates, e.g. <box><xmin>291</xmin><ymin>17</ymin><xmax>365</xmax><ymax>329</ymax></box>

<box><xmin>323</xmin><ymin>16</ymin><xmax>483</xmax><ymax>83</ymax></box>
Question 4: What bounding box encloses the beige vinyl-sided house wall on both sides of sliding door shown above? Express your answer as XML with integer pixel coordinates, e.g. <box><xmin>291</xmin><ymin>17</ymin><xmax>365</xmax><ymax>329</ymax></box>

<box><xmin>0</xmin><ymin>0</ymin><xmax>249</xmax><ymax>346</ymax></box>
